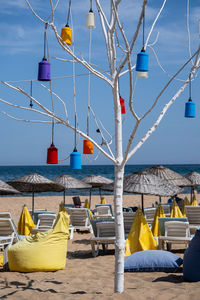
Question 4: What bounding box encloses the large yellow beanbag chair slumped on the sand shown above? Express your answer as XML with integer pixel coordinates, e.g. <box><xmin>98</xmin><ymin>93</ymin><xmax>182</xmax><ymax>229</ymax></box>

<box><xmin>8</xmin><ymin>211</ymin><xmax>69</xmax><ymax>272</ymax></box>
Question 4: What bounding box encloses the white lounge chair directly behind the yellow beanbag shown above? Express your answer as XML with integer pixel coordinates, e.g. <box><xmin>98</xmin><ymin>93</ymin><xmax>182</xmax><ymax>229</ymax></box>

<box><xmin>32</xmin><ymin>213</ymin><xmax>56</xmax><ymax>233</ymax></box>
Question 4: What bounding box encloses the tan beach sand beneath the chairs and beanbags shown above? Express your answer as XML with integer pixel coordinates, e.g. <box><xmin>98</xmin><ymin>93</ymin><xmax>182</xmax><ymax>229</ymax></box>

<box><xmin>0</xmin><ymin>195</ymin><xmax>200</xmax><ymax>300</ymax></box>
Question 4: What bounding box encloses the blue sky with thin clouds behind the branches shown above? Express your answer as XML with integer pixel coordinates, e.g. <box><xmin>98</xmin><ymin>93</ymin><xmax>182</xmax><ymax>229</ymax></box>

<box><xmin>0</xmin><ymin>0</ymin><xmax>200</xmax><ymax>165</ymax></box>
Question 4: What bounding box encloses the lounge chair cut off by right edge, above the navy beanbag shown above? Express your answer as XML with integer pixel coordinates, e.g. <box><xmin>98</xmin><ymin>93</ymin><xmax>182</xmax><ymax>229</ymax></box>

<box><xmin>185</xmin><ymin>205</ymin><xmax>200</xmax><ymax>231</ymax></box>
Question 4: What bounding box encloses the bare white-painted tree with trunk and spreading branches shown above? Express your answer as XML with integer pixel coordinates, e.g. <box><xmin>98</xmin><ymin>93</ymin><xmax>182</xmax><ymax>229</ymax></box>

<box><xmin>0</xmin><ymin>0</ymin><xmax>200</xmax><ymax>293</ymax></box>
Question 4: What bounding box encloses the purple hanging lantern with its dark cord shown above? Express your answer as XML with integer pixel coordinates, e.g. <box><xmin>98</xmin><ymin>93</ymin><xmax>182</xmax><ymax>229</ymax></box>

<box><xmin>38</xmin><ymin>23</ymin><xmax>51</xmax><ymax>81</ymax></box>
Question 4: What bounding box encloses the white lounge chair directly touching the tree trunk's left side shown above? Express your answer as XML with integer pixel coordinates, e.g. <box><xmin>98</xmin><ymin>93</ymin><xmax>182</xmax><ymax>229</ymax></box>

<box><xmin>90</xmin><ymin>221</ymin><xmax>116</xmax><ymax>257</ymax></box>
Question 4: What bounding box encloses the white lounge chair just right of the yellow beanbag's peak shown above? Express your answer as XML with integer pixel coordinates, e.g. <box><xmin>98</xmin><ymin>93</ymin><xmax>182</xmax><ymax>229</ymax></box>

<box><xmin>69</xmin><ymin>208</ymin><xmax>93</xmax><ymax>233</ymax></box>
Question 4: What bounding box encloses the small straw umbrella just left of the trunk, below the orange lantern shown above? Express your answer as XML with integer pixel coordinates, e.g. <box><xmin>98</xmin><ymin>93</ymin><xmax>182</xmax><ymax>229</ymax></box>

<box><xmin>81</xmin><ymin>175</ymin><xmax>113</xmax><ymax>204</ymax></box>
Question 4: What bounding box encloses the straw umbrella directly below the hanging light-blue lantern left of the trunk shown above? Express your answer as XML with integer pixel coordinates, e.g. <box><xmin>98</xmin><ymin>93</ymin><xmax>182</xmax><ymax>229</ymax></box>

<box><xmin>53</xmin><ymin>174</ymin><xmax>92</xmax><ymax>203</ymax></box>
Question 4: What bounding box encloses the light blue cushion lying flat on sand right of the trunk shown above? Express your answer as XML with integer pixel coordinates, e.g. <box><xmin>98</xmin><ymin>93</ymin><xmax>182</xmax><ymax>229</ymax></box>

<box><xmin>124</xmin><ymin>250</ymin><xmax>183</xmax><ymax>272</ymax></box>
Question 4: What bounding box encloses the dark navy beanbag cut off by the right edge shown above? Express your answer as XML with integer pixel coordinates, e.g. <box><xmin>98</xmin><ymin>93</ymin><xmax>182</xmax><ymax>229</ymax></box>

<box><xmin>183</xmin><ymin>228</ymin><xmax>200</xmax><ymax>281</ymax></box>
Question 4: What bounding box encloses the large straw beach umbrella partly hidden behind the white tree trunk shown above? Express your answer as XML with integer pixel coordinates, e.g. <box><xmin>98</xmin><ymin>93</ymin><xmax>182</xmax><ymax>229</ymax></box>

<box><xmin>102</xmin><ymin>171</ymin><xmax>182</xmax><ymax>210</ymax></box>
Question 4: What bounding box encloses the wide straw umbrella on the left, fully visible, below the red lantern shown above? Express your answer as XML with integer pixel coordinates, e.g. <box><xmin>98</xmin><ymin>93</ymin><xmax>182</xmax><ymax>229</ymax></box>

<box><xmin>8</xmin><ymin>173</ymin><xmax>65</xmax><ymax>215</ymax></box>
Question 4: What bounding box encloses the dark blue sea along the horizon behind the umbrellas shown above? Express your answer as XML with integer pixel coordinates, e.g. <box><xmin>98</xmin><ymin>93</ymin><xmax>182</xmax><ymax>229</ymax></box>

<box><xmin>0</xmin><ymin>164</ymin><xmax>200</xmax><ymax>196</ymax></box>
